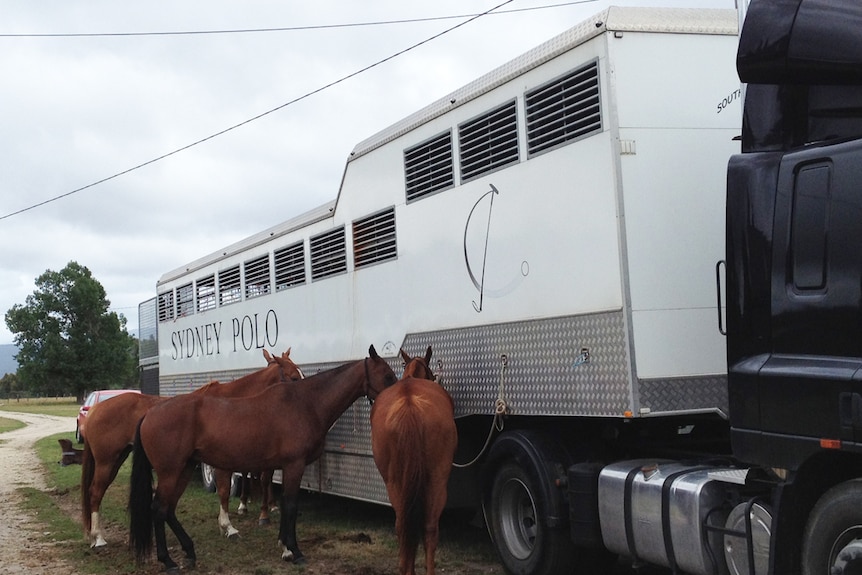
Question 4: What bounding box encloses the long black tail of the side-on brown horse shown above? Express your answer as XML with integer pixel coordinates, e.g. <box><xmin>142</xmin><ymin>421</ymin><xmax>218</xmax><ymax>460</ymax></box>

<box><xmin>129</xmin><ymin>419</ymin><xmax>153</xmax><ymax>561</ymax></box>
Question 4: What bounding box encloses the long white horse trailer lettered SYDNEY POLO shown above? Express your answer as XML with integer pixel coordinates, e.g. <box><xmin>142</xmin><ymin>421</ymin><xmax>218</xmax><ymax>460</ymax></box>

<box><xmin>141</xmin><ymin>7</ymin><xmax>741</xmax><ymax>572</ymax></box>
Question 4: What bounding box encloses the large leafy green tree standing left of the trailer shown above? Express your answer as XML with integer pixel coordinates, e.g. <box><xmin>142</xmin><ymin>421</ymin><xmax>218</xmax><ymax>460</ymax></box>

<box><xmin>6</xmin><ymin>261</ymin><xmax>138</xmax><ymax>401</ymax></box>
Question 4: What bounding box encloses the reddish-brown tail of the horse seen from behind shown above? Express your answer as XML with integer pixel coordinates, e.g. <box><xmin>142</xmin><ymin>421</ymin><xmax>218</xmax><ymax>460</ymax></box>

<box><xmin>391</xmin><ymin>394</ymin><xmax>429</xmax><ymax>549</ymax></box>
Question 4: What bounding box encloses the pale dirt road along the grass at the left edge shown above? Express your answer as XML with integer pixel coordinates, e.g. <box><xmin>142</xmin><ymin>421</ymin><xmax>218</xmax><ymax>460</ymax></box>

<box><xmin>0</xmin><ymin>412</ymin><xmax>75</xmax><ymax>575</ymax></box>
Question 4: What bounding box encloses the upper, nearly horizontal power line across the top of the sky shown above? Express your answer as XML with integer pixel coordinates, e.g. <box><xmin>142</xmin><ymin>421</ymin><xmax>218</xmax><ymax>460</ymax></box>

<box><xmin>0</xmin><ymin>0</ymin><xmax>598</xmax><ymax>38</ymax></box>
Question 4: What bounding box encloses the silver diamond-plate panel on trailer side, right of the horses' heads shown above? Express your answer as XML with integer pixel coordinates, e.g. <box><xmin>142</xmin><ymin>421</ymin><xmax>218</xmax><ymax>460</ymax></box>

<box><xmin>403</xmin><ymin>312</ymin><xmax>632</xmax><ymax>417</ymax></box>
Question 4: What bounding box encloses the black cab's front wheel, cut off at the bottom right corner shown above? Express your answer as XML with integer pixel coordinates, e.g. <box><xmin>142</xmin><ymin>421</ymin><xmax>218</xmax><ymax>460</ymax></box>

<box><xmin>802</xmin><ymin>479</ymin><xmax>862</xmax><ymax>575</ymax></box>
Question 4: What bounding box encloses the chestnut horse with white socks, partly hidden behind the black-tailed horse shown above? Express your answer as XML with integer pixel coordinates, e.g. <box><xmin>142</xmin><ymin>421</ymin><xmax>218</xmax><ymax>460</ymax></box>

<box><xmin>81</xmin><ymin>349</ymin><xmax>302</xmax><ymax>547</ymax></box>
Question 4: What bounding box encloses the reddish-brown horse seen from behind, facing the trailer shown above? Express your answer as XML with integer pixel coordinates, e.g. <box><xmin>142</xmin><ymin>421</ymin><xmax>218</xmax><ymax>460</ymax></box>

<box><xmin>371</xmin><ymin>346</ymin><xmax>458</xmax><ymax>575</ymax></box>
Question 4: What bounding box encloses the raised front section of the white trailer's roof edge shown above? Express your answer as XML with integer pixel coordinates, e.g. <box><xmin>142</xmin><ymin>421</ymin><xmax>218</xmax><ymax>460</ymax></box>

<box><xmin>347</xmin><ymin>6</ymin><xmax>739</xmax><ymax>162</ymax></box>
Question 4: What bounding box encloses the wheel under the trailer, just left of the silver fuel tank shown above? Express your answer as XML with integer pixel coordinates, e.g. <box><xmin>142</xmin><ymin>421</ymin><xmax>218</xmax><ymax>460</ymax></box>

<box><xmin>488</xmin><ymin>462</ymin><xmax>575</xmax><ymax>575</ymax></box>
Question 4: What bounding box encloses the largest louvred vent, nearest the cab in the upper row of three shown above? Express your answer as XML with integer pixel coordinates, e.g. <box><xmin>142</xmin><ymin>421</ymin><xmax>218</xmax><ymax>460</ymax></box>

<box><xmin>526</xmin><ymin>62</ymin><xmax>602</xmax><ymax>155</ymax></box>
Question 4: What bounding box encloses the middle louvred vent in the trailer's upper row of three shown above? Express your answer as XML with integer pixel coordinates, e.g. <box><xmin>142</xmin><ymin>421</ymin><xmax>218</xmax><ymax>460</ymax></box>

<box><xmin>458</xmin><ymin>100</ymin><xmax>518</xmax><ymax>182</ymax></box>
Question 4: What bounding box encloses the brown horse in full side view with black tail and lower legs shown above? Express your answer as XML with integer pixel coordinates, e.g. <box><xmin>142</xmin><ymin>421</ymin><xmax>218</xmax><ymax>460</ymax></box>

<box><xmin>129</xmin><ymin>346</ymin><xmax>396</xmax><ymax>572</ymax></box>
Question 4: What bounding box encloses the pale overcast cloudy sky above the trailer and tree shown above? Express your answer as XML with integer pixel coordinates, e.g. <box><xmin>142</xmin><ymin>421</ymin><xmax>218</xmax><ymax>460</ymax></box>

<box><xmin>0</xmin><ymin>0</ymin><xmax>735</xmax><ymax>344</ymax></box>
